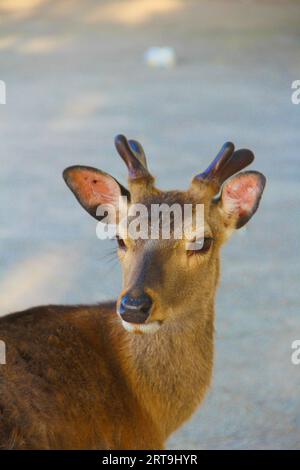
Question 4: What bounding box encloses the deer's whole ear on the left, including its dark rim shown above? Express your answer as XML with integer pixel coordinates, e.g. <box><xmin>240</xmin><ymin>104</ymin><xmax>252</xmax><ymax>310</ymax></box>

<box><xmin>63</xmin><ymin>165</ymin><xmax>130</xmax><ymax>220</ymax></box>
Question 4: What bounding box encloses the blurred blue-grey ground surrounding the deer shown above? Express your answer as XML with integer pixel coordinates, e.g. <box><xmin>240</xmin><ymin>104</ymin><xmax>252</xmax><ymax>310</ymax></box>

<box><xmin>0</xmin><ymin>0</ymin><xmax>300</xmax><ymax>449</ymax></box>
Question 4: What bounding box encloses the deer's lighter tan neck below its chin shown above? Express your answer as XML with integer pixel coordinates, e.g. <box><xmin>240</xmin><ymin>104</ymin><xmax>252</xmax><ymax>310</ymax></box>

<box><xmin>122</xmin><ymin>299</ymin><xmax>214</xmax><ymax>437</ymax></box>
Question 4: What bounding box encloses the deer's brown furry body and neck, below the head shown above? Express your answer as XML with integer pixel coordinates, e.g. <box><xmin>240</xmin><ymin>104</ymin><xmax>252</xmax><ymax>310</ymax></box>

<box><xmin>0</xmin><ymin>298</ymin><xmax>213</xmax><ymax>449</ymax></box>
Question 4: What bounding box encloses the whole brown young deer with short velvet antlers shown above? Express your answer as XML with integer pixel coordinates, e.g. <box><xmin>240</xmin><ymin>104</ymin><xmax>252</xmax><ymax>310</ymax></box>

<box><xmin>0</xmin><ymin>136</ymin><xmax>265</xmax><ymax>449</ymax></box>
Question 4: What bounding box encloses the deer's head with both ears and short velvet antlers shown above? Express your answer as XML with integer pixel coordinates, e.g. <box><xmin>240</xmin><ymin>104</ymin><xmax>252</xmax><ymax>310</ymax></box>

<box><xmin>64</xmin><ymin>136</ymin><xmax>265</xmax><ymax>333</ymax></box>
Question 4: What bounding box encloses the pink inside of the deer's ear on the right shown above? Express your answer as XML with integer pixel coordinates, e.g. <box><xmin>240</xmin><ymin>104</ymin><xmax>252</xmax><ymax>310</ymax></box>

<box><xmin>222</xmin><ymin>174</ymin><xmax>262</xmax><ymax>218</ymax></box>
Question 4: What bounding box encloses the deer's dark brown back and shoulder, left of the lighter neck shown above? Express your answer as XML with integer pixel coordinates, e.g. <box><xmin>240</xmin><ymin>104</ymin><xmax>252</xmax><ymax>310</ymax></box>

<box><xmin>0</xmin><ymin>304</ymin><xmax>162</xmax><ymax>449</ymax></box>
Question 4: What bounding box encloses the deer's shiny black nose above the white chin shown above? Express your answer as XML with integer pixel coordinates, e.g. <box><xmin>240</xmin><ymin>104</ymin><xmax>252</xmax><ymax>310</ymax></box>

<box><xmin>119</xmin><ymin>293</ymin><xmax>152</xmax><ymax>323</ymax></box>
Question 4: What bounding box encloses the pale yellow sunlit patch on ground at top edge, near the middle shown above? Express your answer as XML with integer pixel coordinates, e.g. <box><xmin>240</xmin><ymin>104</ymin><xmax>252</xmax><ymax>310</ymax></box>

<box><xmin>86</xmin><ymin>0</ymin><xmax>183</xmax><ymax>24</ymax></box>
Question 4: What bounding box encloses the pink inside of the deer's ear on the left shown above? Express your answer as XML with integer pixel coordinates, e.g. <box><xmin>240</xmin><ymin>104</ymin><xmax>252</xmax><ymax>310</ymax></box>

<box><xmin>69</xmin><ymin>169</ymin><xmax>121</xmax><ymax>207</ymax></box>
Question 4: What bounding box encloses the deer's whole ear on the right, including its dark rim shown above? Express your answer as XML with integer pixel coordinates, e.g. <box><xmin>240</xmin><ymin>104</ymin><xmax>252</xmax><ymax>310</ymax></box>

<box><xmin>218</xmin><ymin>171</ymin><xmax>266</xmax><ymax>229</ymax></box>
